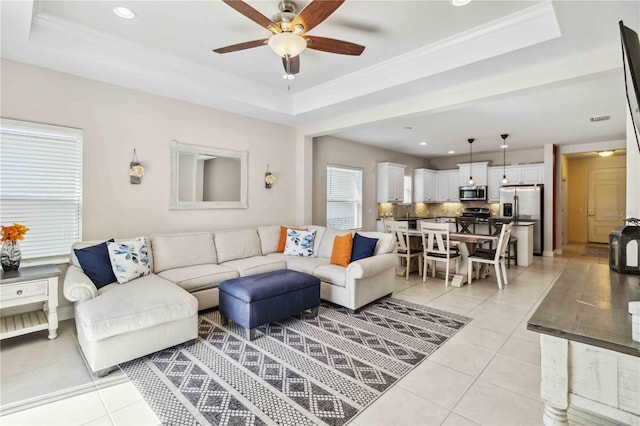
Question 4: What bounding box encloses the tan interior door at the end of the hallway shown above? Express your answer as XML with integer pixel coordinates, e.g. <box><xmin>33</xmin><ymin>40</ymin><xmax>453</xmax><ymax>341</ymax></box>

<box><xmin>587</xmin><ymin>167</ymin><xmax>626</xmax><ymax>243</ymax></box>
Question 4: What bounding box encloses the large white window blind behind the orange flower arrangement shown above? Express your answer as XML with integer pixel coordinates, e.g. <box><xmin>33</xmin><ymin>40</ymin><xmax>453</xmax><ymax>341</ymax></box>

<box><xmin>0</xmin><ymin>119</ymin><xmax>83</xmax><ymax>259</ymax></box>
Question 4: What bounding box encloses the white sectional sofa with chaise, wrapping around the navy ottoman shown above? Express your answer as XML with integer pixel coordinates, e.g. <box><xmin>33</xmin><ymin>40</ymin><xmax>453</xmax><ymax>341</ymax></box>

<box><xmin>64</xmin><ymin>225</ymin><xmax>397</xmax><ymax>372</ymax></box>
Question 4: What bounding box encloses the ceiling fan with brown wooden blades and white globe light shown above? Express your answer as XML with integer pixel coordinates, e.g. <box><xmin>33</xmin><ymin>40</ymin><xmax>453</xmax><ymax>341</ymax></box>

<box><xmin>213</xmin><ymin>0</ymin><xmax>364</xmax><ymax>80</ymax></box>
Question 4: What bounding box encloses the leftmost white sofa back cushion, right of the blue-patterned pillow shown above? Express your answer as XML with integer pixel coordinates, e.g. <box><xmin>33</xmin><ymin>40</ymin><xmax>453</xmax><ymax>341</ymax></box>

<box><xmin>151</xmin><ymin>232</ymin><xmax>218</xmax><ymax>273</ymax></box>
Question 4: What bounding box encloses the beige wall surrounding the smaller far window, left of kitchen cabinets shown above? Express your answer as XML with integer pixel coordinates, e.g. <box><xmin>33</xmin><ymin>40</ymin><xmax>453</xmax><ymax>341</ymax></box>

<box><xmin>312</xmin><ymin>136</ymin><xmax>427</xmax><ymax>231</ymax></box>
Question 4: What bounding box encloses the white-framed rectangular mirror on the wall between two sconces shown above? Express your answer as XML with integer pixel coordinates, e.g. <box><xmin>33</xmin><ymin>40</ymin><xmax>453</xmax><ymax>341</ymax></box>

<box><xmin>169</xmin><ymin>141</ymin><xmax>249</xmax><ymax>209</ymax></box>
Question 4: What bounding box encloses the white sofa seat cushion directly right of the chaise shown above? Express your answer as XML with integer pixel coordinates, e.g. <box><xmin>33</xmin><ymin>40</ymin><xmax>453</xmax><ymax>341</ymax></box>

<box><xmin>158</xmin><ymin>264</ymin><xmax>240</xmax><ymax>292</ymax></box>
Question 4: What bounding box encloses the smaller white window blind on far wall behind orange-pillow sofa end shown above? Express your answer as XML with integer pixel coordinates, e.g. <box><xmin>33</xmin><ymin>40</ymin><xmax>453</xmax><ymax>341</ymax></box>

<box><xmin>327</xmin><ymin>166</ymin><xmax>362</xmax><ymax>229</ymax></box>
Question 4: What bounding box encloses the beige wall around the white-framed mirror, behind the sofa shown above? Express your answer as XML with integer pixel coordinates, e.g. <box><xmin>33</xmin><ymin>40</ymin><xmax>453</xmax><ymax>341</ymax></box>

<box><xmin>0</xmin><ymin>60</ymin><xmax>296</xmax><ymax>317</ymax></box>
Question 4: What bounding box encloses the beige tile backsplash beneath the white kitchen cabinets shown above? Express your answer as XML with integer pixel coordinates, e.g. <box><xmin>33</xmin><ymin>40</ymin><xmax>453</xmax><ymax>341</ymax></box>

<box><xmin>378</xmin><ymin>201</ymin><xmax>500</xmax><ymax>218</ymax></box>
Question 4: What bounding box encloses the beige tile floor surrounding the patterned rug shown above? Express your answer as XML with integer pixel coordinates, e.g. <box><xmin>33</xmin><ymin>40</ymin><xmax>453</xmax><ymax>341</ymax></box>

<box><xmin>0</xmin><ymin>244</ymin><xmax>607</xmax><ymax>426</ymax></box>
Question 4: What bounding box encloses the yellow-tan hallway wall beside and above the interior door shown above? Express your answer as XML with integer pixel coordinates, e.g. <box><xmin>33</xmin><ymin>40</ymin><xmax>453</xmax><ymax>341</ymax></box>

<box><xmin>563</xmin><ymin>155</ymin><xmax>627</xmax><ymax>243</ymax></box>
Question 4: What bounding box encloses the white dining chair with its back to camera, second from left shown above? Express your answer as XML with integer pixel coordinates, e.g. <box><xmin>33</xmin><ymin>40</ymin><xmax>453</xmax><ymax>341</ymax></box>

<box><xmin>420</xmin><ymin>222</ymin><xmax>460</xmax><ymax>287</ymax></box>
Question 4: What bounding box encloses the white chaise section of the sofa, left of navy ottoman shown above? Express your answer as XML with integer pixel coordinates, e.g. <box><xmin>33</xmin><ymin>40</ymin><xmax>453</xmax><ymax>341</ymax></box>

<box><xmin>76</xmin><ymin>274</ymin><xmax>198</xmax><ymax>375</ymax></box>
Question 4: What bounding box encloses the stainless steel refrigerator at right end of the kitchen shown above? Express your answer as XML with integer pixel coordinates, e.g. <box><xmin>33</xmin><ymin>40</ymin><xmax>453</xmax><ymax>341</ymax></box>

<box><xmin>500</xmin><ymin>185</ymin><xmax>544</xmax><ymax>256</ymax></box>
